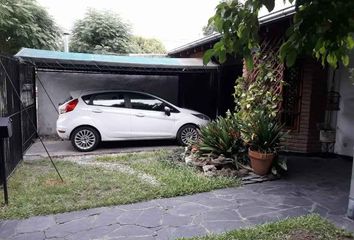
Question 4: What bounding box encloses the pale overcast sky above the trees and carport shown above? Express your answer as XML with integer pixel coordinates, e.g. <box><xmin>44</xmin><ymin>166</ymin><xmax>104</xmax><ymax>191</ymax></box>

<box><xmin>37</xmin><ymin>0</ymin><xmax>292</xmax><ymax>50</ymax></box>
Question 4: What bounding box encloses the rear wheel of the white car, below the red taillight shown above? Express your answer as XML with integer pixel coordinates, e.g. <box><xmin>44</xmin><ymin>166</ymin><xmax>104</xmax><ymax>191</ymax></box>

<box><xmin>71</xmin><ymin>126</ymin><xmax>101</xmax><ymax>152</ymax></box>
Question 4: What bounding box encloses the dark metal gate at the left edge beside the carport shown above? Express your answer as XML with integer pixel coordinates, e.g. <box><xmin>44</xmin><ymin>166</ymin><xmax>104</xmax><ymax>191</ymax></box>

<box><xmin>0</xmin><ymin>55</ymin><xmax>37</xmax><ymax>183</ymax></box>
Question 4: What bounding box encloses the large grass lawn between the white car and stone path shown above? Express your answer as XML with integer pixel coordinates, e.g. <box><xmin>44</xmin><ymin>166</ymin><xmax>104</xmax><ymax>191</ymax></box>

<box><xmin>0</xmin><ymin>151</ymin><xmax>239</xmax><ymax>219</ymax></box>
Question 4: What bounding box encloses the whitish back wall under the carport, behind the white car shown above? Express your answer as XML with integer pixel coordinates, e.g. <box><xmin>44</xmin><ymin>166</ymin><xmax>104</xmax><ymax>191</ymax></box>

<box><xmin>37</xmin><ymin>72</ymin><xmax>178</xmax><ymax>136</ymax></box>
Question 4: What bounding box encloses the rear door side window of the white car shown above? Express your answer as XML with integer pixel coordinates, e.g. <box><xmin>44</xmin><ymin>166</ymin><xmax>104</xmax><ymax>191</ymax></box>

<box><xmin>88</xmin><ymin>92</ymin><xmax>125</xmax><ymax>108</ymax></box>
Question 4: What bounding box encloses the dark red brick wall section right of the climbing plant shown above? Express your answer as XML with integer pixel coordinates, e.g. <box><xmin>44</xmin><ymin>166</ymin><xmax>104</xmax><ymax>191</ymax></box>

<box><xmin>283</xmin><ymin>59</ymin><xmax>326</xmax><ymax>153</ymax></box>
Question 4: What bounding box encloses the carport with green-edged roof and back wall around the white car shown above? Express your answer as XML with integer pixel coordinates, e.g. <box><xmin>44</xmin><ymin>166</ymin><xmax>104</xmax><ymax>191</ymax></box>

<box><xmin>16</xmin><ymin>48</ymin><xmax>220</xmax><ymax>136</ymax></box>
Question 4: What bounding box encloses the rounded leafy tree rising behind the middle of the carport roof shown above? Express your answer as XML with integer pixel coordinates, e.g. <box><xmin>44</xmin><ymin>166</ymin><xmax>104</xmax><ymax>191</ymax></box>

<box><xmin>70</xmin><ymin>9</ymin><xmax>131</xmax><ymax>54</ymax></box>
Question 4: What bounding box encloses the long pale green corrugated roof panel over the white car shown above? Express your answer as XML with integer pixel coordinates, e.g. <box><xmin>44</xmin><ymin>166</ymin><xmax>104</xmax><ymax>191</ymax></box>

<box><xmin>15</xmin><ymin>48</ymin><xmax>218</xmax><ymax>68</ymax></box>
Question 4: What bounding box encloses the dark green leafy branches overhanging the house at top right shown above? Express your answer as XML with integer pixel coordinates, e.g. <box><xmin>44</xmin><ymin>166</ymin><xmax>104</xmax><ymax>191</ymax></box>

<box><xmin>204</xmin><ymin>0</ymin><xmax>354</xmax><ymax>68</ymax></box>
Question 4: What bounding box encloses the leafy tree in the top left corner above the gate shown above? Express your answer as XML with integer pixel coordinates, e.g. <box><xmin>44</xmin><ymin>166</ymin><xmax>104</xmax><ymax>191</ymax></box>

<box><xmin>0</xmin><ymin>0</ymin><xmax>61</xmax><ymax>54</ymax></box>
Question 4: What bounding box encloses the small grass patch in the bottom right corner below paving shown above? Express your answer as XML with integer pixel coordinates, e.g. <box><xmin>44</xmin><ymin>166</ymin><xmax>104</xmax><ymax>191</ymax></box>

<box><xmin>184</xmin><ymin>215</ymin><xmax>354</xmax><ymax>240</ymax></box>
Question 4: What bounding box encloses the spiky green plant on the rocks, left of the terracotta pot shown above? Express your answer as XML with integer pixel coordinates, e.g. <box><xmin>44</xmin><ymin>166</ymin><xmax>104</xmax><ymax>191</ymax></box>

<box><xmin>194</xmin><ymin>113</ymin><xmax>243</xmax><ymax>157</ymax></box>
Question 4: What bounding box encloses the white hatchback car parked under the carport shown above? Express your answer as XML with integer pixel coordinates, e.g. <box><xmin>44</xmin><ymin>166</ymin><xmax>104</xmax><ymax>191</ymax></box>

<box><xmin>57</xmin><ymin>90</ymin><xmax>210</xmax><ymax>152</ymax></box>
